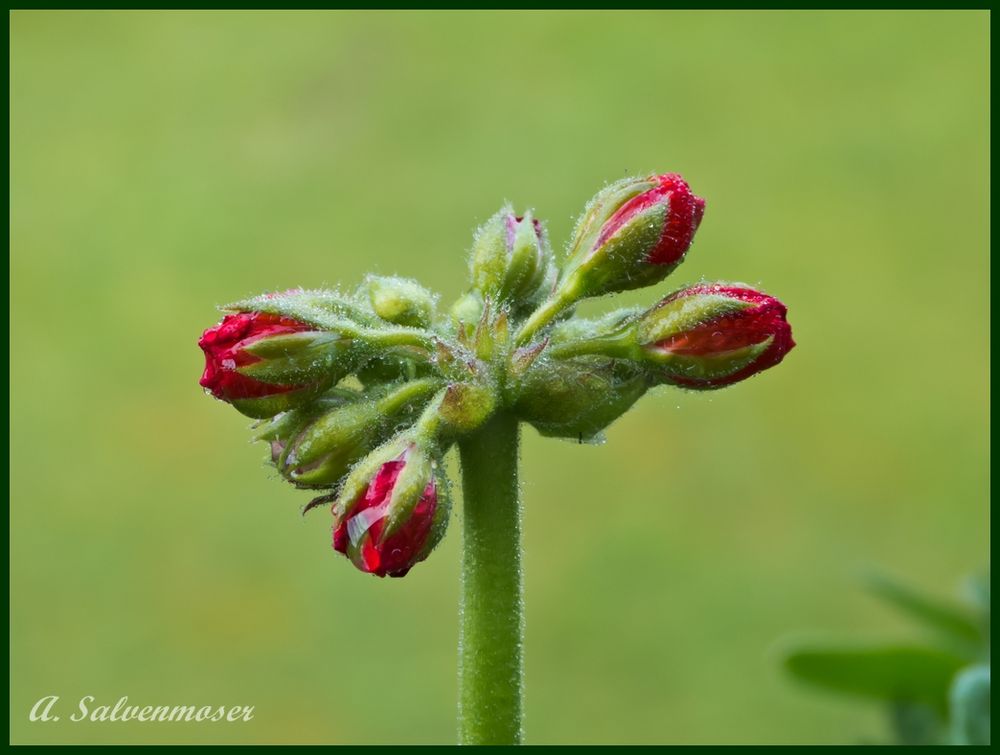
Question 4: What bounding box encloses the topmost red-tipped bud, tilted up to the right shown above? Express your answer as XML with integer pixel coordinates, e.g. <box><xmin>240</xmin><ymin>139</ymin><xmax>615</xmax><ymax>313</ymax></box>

<box><xmin>560</xmin><ymin>173</ymin><xmax>705</xmax><ymax>299</ymax></box>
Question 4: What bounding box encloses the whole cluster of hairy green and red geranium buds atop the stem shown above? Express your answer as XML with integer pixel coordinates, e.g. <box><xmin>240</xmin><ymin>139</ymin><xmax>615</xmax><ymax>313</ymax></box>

<box><xmin>199</xmin><ymin>174</ymin><xmax>794</xmax><ymax>577</ymax></box>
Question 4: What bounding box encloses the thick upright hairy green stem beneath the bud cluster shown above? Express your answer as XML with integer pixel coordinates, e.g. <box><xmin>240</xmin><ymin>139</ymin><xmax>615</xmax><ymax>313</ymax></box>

<box><xmin>458</xmin><ymin>414</ymin><xmax>524</xmax><ymax>744</ymax></box>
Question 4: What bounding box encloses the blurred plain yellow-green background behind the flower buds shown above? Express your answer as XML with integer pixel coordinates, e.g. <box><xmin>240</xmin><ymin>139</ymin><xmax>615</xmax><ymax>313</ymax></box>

<box><xmin>10</xmin><ymin>12</ymin><xmax>990</xmax><ymax>743</ymax></box>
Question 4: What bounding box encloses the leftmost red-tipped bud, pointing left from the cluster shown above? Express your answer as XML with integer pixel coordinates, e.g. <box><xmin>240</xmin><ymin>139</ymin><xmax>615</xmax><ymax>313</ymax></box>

<box><xmin>198</xmin><ymin>312</ymin><xmax>350</xmax><ymax>417</ymax></box>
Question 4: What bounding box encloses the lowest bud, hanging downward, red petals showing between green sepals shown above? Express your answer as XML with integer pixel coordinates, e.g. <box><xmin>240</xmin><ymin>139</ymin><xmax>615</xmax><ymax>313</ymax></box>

<box><xmin>333</xmin><ymin>441</ymin><xmax>450</xmax><ymax>577</ymax></box>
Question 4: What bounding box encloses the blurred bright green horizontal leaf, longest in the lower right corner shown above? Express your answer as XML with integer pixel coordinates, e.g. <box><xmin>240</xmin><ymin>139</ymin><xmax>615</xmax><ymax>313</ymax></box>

<box><xmin>784</xmin><ymin>644</ymin><xmax>964</xmax><ymax>713</ymax></box>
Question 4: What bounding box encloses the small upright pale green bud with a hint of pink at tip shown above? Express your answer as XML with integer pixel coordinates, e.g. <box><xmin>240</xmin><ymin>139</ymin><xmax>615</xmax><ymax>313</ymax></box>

<box><xmin>471</xmin><ymin>206</ymin><xmax>556</xmax><ymax>306</ymax></box>
